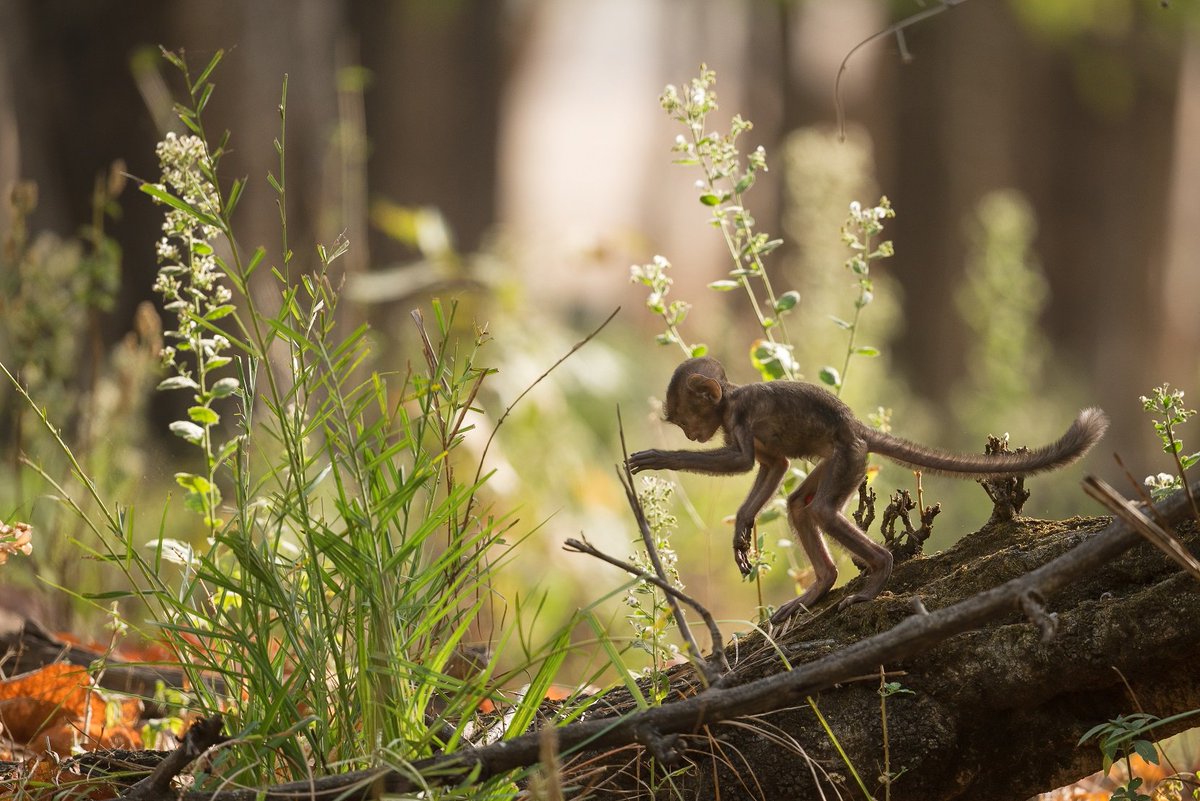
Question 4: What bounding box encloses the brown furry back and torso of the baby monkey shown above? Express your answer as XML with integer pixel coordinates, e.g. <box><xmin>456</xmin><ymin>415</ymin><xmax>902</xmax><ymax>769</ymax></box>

<box><xmin>733</xmin><ymin>381</ymin><xmax>858</xmax><ymax>459</ymax></box>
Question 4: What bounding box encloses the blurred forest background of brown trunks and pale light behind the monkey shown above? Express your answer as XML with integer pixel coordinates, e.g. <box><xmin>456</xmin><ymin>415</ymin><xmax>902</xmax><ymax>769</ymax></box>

<box><xmin>0</xmin><ymin>0</ymin><xmax>1200</xmax><ymax>647</ymax></box>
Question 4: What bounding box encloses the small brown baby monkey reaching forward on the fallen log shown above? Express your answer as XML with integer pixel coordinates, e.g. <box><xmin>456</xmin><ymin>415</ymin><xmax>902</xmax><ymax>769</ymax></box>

<box><xmin>629</xmin><ymin>357</ymin><xmax>1109</xmax><ymax>624</ymax></box>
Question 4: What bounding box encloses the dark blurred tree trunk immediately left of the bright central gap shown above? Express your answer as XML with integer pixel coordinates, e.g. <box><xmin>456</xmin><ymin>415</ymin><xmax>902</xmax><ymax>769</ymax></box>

<box><xmin>349</xmin><ymin>0</ymin><xmax>506</xmax><ymax>261</ymax></box>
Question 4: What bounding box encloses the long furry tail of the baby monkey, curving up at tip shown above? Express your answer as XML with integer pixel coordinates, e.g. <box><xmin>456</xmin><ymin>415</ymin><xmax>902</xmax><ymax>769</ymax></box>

<box><xmin>859</xmin><ymin>408</ymin><xmax>1109</xmax><ymax>478</ymax></box>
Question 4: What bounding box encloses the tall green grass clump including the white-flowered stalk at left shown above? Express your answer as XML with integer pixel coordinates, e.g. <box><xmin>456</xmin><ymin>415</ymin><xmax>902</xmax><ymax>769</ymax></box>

<box><xmin>4</xmin><ymin>53</ymin><xmax>600</xmax><ymax>797</ymax></box>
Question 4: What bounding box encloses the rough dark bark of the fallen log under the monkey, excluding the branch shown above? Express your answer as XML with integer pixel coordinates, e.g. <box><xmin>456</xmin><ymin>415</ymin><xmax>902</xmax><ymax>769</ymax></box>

<box><xmin>566</xmin><ymin>510</ymin><xmax>1200</xmax><ymax>801</ymax></box>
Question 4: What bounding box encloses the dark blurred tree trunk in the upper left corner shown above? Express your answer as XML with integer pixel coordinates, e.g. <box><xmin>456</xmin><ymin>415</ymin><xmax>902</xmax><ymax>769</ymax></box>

<box><xmin>0</xmin><ymin>0</ymin><xmax>167</xmax><ymax>338</ymax></box>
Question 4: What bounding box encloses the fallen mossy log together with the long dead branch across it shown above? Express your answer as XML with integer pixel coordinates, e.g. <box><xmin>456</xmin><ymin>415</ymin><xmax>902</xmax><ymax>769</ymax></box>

<box><xmin>142</xmin><ymin>479</ymin><xmax>1200</xmax><ymax>801</ymax></box>
